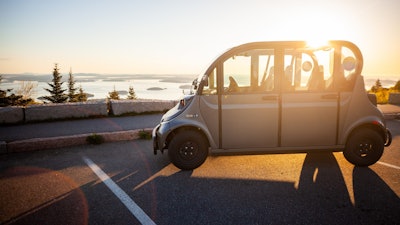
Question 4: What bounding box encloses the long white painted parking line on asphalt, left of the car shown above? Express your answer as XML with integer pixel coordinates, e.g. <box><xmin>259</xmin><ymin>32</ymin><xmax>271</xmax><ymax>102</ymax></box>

<box><xmin>82</xmin><ymin>156</ymin><xmax>155</xmax><ymax>225</ymax></box>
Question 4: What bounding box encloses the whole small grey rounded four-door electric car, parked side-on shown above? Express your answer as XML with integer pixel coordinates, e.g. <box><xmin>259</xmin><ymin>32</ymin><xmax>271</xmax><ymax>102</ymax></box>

<box><xmin>153</xmin><ymin>41</ymin><xmax>391</xmax><ymax>169</ymax></box>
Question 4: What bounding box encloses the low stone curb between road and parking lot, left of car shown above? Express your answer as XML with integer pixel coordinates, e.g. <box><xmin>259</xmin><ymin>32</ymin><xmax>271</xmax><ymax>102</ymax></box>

<box><xmin>1</xmin><ymin>128</ymin><xmax>153</xmax><ymax>153</ymax></box>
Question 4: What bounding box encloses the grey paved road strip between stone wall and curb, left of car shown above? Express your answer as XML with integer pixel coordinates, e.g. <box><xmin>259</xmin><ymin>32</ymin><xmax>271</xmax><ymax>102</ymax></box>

<box><xmin>0</xmin><ymin>114</ymin><xmax>162</xmax><ymax>142</ymax></box>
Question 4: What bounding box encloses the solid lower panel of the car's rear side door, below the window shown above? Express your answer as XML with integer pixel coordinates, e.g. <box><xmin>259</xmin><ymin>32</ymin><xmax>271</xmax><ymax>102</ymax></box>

<box><xmin>281</xmin><ymin>92</ymin><xmax>338</xmax><ymax>147</ymax></box>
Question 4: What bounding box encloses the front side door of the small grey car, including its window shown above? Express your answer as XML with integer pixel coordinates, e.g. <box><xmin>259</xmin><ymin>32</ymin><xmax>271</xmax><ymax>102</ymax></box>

<box><xmin>220</xmin><ymin>49</ymin><xmax>279</xmax><ymax>150</ymax></box>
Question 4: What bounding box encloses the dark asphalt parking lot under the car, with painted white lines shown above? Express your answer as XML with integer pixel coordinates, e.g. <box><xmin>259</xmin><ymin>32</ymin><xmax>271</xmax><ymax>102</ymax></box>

<box><xmin>0</xmin><ymin>120</ymin><xmax>400</xmax><ymax>224</ymax></box>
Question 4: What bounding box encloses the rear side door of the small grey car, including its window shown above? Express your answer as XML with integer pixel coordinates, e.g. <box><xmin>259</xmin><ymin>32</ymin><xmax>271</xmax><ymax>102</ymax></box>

<box><xmin>281</xmin><ymin>51</ymin><xmax>339</xmax><ymax>147</ymax></box>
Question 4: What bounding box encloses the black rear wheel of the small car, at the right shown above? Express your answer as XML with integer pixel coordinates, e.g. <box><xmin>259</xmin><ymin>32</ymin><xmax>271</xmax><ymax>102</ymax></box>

<box><xmin>343</xmin><ymin>129</ymin><xmax>385</xmax><ymax>166</ymax></box>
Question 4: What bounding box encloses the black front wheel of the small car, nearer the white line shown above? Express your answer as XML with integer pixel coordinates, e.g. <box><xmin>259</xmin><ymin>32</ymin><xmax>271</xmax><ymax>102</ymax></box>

<box><xmin>168</xmin><ymin>130</ymin><xmax>208</xmax><ymax>170</ymax></box>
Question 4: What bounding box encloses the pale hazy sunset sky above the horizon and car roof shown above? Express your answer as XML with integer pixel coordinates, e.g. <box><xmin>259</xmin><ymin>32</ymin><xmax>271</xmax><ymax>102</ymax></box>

<box><xmin>0</xmin><ymin>0</ymin><xmax>400</xmax><ymax>76</ymax></box>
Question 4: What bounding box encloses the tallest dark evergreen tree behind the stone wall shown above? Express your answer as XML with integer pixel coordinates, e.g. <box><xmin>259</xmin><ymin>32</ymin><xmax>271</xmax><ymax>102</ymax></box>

<box><xmin>43</xmin><ymin>63</ymin><xmax>68</xmax><ymax>103</ymax></box>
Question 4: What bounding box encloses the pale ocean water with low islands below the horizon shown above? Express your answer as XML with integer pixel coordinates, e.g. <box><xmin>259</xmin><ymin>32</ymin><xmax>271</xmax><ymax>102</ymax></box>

<box><xmin>0</xmin><ymin>73</ymin><xmax>400</xmax><ymax>102</ymax></box>
